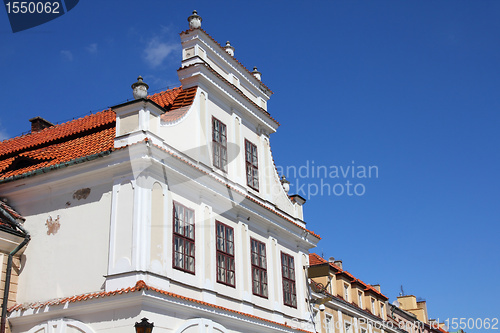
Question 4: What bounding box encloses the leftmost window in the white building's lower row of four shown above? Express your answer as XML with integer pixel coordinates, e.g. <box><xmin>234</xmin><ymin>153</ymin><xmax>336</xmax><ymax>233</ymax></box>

<box><xmin>172</xmin><ymin>202</ymin><xmax>194</xmax><ymax>274</ymax></box>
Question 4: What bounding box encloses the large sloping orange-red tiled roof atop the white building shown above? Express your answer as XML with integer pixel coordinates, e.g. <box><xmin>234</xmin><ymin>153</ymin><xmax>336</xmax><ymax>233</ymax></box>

<box><xmin>0</xmin><ymin>87</ymin><xmax>196</xmax><ymax>181</ymax></box>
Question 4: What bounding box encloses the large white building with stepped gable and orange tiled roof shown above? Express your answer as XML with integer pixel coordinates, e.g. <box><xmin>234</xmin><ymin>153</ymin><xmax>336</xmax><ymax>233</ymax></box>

<box><xmin>0</xmin><ymin>13</ymin><xmax>319</xmax><ymax>333</ymax></box>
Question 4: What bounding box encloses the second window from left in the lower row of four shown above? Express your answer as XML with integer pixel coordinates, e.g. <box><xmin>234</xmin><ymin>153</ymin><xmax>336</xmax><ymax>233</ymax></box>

<box><xmin>215</xmin><ymin>221</ymin><xmax>235</xmax><ymax>287</ymax></box>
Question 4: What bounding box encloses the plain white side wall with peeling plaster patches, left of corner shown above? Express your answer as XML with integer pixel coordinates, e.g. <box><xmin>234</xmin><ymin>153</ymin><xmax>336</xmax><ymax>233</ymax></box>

<box><xmin>16</xmin><ymin>184</ymin><xmax>111</xmax><ymax>303</ymax></box>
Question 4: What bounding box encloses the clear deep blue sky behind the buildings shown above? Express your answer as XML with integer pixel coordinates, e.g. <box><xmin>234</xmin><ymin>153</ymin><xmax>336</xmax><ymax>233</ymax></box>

<box><xmin>0</xmin><ymin>0</ymin><xmax>500</xmax><ymax>332</ymax></box>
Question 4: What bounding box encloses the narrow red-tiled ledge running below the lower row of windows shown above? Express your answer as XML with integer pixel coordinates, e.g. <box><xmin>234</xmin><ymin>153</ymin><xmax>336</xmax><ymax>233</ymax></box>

<box><xmin>8</xmin><ymin>280</ymin><xmax>310</xmax><ymax>333</ymax></box>
